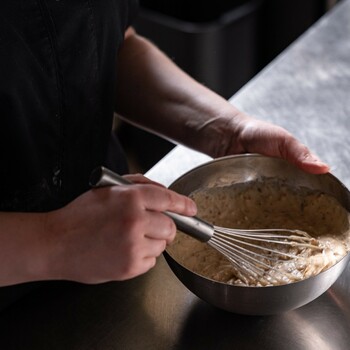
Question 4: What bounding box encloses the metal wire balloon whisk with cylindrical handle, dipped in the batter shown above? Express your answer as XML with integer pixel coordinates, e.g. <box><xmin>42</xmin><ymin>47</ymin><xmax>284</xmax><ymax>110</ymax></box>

<box><xmin>90</xmin><ymin>167</ymin><xmax>322</xmax><ymax>281</ymax></box>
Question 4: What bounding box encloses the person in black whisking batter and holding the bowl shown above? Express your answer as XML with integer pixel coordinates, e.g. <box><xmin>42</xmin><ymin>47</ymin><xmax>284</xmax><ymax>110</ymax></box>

<box><xmin>0</xmin><ymin>0</ymin><xmax>329</xmax><ymax>286</ymax></box>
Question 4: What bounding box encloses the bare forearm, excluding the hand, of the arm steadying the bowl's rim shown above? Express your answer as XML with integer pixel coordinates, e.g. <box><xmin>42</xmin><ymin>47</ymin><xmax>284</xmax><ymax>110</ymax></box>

<box><xmin>117</xmin><ymin>28</ymin><xmax>244</xmax><ymax>156</ymax></box>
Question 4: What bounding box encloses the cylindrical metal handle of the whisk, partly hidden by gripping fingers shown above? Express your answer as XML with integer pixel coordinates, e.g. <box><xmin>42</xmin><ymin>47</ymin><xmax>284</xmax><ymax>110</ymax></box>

<box><xmin>90</xmin><ymin>167</ymin><xmax>214</xmax><ymax>242</ymax></box>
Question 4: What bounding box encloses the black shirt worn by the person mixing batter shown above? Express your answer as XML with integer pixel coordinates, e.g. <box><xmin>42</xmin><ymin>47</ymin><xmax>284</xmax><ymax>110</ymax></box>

<box><xmin>0</xmin><ymin>0</ymin><xmax>137</xmax><ymax>211</ymax></box>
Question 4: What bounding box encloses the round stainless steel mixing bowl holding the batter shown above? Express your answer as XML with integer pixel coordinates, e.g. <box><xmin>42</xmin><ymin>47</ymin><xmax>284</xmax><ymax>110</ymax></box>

<box><xmin>164</xmin><ymin>154</ymin><xmax>350</xmax><ymax>315</ymax></box>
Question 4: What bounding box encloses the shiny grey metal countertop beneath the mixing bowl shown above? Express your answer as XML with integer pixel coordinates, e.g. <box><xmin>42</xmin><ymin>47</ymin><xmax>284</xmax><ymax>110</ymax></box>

<box><xmin>0</xmin><ymin>0</ymin><xmax>350</xmax><ymax>350</ymax></box>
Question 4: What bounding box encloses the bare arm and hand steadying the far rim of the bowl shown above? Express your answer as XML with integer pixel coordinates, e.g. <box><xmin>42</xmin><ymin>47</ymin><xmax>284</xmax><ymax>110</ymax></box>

<box><xmin>117</xmin><ymin>28</ymin><xmax>329</xmax><ymax>173</ymax></box>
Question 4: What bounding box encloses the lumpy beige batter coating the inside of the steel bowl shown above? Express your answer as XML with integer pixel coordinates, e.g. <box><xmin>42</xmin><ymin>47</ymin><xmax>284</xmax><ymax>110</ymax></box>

<box><xmin>167</xmin><ymin>179</ymin><xmax>350</xmax><ymax>287</ymax></box>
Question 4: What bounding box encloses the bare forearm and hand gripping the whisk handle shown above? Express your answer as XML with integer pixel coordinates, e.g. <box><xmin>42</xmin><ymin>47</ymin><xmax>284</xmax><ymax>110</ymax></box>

<box><xmin>0</xmin><ymin>175</ymin><xmax>195</xmax><ymax>286</ymax></box>
